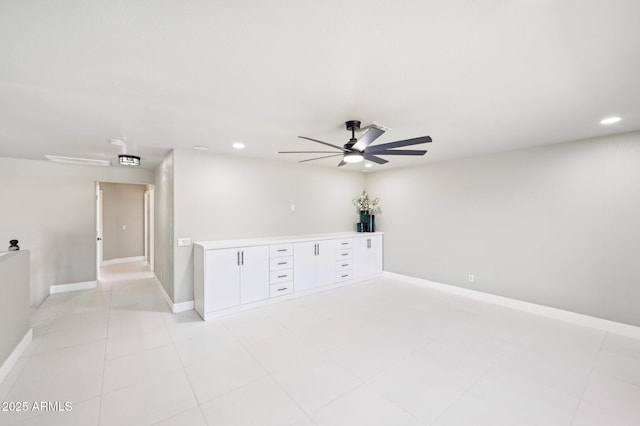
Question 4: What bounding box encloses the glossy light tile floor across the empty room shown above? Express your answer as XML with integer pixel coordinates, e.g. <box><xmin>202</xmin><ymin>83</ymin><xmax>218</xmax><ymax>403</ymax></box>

<box><xmin>0</xmin><ymin>272</ymin><xmax>640</xmax><ymax>426</ymax></box>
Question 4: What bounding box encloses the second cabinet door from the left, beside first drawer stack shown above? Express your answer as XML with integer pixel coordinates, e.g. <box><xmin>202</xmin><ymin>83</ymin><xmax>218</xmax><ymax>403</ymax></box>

<box><xmin>239</xmin><ymin>246</ymin><xmax>269</xmax><ymax>303</ymax></box>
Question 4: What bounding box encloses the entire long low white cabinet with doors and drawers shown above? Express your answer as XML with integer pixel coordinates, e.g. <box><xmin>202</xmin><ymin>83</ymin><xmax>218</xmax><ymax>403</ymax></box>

<box><xmin>193</xmin><ymin>232</ymin><xmax>382</xmax><ymax>319</ymax></box>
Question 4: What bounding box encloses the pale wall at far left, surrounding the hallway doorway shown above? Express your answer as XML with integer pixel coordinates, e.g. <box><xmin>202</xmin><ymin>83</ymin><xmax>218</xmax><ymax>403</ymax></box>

<box><xmin>0</xmin><ymin>157</ymin><xmax>153</xmax><ymax>305</ymax></box>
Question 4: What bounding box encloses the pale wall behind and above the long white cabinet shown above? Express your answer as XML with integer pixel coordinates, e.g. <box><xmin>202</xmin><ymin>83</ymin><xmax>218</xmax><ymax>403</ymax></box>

<box><xmin>173</xmin><ymin>150</ymin><xmax>364</xmax><ymax>302</ymax></box>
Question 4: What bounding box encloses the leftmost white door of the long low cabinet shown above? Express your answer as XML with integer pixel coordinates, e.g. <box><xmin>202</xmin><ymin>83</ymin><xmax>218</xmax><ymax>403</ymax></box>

<box><xmin>204</xmin><ymin>249</ymin><xmax>240</xmax><ymax>312</ymax></box>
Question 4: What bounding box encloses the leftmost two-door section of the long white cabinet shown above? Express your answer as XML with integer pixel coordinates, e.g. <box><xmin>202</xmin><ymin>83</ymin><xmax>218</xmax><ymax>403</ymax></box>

<box><xmin>204</xmin><ymin>246</ymin><xmax>269</xmax><ymax>313</ymax></box>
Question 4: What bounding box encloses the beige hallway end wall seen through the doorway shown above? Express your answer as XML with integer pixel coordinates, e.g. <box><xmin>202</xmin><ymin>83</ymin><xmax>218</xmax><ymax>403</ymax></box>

<box><xmin>100</xmin><ymin>182</ymin><xmax>147</xmax><ymax>260</ymax></box>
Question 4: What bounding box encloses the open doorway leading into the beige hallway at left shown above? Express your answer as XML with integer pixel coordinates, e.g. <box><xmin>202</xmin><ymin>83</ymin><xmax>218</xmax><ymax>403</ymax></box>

<box><xmin>96</xmin><ymin>182</ymin><xmax>154</xmax><ymax>281</ymax></box>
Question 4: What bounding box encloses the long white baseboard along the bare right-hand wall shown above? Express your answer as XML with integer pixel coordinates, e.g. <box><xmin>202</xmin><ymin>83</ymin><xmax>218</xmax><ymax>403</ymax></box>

<box><xmin>383</xmin><ymin>271</ymin><xmax>640</xmax><ymax>339</ymax></box>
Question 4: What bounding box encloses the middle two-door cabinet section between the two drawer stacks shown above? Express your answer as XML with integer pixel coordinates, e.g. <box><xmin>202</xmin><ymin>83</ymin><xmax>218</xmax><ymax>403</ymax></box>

<box><xmin>293</xmin><ymin>240</ymin><xmax>336</xmax><ymax>292</ymax></box>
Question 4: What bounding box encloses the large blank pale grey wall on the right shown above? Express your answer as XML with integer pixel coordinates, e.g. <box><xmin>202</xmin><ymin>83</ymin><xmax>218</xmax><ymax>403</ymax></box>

<box><xmin>366</xmin><ymin>132</ymin><xmax>640</xmax><ymax>326</ymax></box>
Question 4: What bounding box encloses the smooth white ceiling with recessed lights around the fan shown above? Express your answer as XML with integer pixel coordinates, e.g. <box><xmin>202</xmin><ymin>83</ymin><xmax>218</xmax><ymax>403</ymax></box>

<box><xmin>0</xmin><ymin>0</ymin><xmax>640</xmax><ymax>170</ymax></box>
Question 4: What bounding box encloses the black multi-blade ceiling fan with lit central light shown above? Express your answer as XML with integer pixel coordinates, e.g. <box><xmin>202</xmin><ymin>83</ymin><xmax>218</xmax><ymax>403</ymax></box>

<box><xmin>279</xmin><ymin>120</ymin><xmax>431</xmax><ymax>167</ymax></box>
